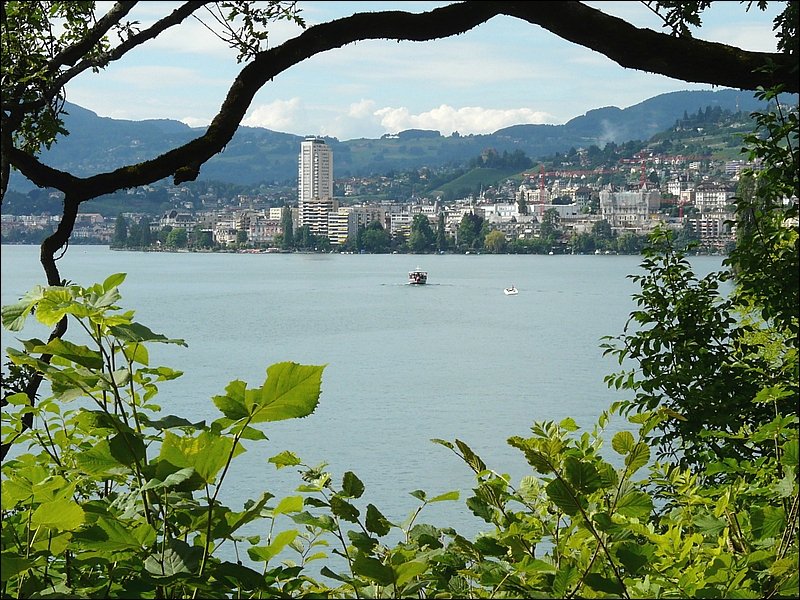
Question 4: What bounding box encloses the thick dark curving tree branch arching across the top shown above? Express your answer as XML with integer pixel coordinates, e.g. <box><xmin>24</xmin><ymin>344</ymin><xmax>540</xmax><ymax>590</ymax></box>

<box><xmin>11</xmin><ymin>1</ymin><xmax>798</xmax><ymax>202</ymax></box>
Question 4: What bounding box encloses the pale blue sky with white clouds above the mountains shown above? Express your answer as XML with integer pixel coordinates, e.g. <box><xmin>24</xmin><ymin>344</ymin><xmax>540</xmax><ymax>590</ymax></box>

<box><xmin>66</xmin><ymin>0</ymin><xmax>780</xmax><ymax>141</ymax></box>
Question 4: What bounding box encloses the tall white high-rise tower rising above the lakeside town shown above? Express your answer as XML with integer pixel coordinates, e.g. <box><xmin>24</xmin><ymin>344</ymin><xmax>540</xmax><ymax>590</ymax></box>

<box><xmin>297</xmin><ymin>137</ymin><xmax>338</xmax><ymax>237</ymax></box>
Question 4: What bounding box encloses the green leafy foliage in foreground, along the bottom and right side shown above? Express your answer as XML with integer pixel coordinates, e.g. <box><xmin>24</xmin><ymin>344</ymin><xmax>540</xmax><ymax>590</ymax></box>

<box><xmin>0</xmin><ymin>3</ymin><xmax>800</xmax><ymax>598</ymax></box>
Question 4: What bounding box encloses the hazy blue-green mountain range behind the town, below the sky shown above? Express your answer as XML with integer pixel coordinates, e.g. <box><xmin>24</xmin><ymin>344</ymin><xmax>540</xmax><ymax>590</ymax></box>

<box><xmin>9</xmin><ymin>89</ymin><xmax>796</xmax><ymax>191</ymax></box>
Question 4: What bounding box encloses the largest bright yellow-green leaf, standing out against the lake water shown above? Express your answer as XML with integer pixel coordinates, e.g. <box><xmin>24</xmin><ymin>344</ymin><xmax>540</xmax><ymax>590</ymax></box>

<box><xmin>245</xmin><ymin>362</ymin><xmax>326</xmax><ymax>423</ymax></box>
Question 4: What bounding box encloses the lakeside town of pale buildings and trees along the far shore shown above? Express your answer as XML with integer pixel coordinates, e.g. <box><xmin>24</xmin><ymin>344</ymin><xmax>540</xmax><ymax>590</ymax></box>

<box><xmin>2</xmin><ymin>129</ymin><xmax>758</xmax><ymax>254</ymax></box>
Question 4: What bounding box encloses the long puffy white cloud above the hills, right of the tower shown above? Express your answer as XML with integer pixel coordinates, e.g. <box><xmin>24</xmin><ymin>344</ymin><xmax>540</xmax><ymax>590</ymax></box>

<box><xmin>375</xmin><ymin>104</ymin><xmax>554</xmax><ymax>135</ymax></box>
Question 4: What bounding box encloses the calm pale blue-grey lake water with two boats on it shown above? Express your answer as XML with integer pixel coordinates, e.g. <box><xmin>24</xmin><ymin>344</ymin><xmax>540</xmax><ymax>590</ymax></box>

<box><xmin>2</xmin><ymin>246</ymin><xmax>721</xmax><ymax>536</ymax></box>
